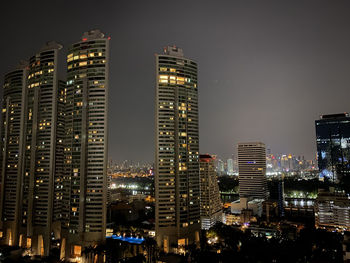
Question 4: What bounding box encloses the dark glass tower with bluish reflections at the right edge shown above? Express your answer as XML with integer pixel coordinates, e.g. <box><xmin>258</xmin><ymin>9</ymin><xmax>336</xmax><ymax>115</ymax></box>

<box><xmin>315</xmin><ymin>113</ymin><xmax>350</xmax><ymax>182</ymax></box>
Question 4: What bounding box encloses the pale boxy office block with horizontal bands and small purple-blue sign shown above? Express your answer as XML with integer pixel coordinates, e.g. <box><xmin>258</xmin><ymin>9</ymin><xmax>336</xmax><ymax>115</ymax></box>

<box><xmin>237</xmin><ymin>142</ymin><xmax>268</xmax><ymax>199</ymax></box>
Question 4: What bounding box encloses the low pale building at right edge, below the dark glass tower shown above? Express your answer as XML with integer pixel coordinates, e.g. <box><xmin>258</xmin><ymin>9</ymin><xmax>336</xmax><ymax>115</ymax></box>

<box><xmin>315</xmin><ymin>188</ymin><xmax>350</xmax><ymax>231</ymax></box>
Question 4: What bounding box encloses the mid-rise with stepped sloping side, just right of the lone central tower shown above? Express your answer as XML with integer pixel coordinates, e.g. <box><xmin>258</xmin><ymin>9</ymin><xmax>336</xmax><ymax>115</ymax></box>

<box><xmin>200</xmin><ymin>154</ymin><xmax>222</xmax><ymax>229</ymax></box>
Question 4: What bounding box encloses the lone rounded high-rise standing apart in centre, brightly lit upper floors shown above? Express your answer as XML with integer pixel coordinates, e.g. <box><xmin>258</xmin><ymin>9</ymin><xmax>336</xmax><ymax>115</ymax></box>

<box><xmin>155</xmin><ymin>46</ymin><xmax>200</xmax><ymax>252</ymax></box>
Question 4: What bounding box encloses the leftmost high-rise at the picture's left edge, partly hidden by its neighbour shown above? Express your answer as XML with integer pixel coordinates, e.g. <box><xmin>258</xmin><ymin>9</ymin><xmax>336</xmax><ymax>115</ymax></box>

<box><xmin>0</xmin><ymin>62</ymin><xmax>28</xmax><ymax>248</ymax></box>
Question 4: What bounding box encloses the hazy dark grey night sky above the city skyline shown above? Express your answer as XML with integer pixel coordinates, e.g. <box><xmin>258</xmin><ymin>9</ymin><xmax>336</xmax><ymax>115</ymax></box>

<box><xmin>0</xmin><ymin>0</ymin><xmax>350</xmax><ymax>161</ymax></box>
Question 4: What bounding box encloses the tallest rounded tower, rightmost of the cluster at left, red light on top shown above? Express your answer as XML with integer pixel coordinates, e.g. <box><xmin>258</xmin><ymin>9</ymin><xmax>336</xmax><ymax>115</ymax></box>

<box><xmin>61</xmin><ymin>30</ymin><xmax>109</xmax><ymax>257</ymax></box>
